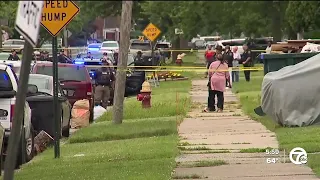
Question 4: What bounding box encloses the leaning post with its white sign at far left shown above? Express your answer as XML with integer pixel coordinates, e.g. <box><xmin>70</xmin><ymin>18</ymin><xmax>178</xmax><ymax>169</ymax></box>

<box><xmin>4</xmin><ymin>1</ymin><xmax>43</xmax><ymax>180</ymax></box>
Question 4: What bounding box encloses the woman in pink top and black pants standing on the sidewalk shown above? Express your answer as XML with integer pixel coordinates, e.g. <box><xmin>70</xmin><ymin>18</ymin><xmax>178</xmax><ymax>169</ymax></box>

<box><xmin>204</xmin><ymin>54</ymin><xmax>231</xmax><ymax>112</ymax></box>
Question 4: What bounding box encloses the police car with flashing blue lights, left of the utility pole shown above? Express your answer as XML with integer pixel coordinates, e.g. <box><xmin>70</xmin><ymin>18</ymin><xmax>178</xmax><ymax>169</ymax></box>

<box><xmin>73</xmin><ymin>51</ymin><xmax>114</xmax><ymax>65</ymax></box>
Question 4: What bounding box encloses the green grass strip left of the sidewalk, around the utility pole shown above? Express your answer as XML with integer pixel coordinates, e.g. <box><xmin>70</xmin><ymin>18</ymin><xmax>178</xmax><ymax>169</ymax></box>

<box><xmin>11</xmin><ymin>73</ymin><xmax>196</xmax><ymax>180</ymax></box>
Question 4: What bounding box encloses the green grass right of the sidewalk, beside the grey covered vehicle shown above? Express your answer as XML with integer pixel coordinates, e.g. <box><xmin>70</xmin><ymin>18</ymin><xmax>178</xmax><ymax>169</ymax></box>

<box><xmin>233</xmin><ymin>65</ymin><xmax>320</xmax><ymax>176</ymax></box>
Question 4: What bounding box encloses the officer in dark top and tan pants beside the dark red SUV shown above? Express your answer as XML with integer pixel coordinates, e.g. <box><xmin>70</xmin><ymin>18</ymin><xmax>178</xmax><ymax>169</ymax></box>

<box><xmin>94</xmin><ymin>60</ymin><xmax>116</xmax><ymax>109</ymax></box>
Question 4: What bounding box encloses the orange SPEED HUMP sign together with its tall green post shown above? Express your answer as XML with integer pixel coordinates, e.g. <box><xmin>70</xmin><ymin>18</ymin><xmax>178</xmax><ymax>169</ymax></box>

<box><xmin>41</xmin><ymin>0</ymin><xmax>80</xmax><ymax>158</ymax></box>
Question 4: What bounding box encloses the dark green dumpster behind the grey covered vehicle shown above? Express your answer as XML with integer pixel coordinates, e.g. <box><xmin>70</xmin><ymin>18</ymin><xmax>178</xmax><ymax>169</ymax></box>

<box><xmin>259</xmin><ymin>53</ymin><xmax>318</xmax><ymax>75</ymax></box>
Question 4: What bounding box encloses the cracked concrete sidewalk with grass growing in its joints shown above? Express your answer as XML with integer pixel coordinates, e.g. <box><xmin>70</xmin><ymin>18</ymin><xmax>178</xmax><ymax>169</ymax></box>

<box><xmin>173</xmin><ymin>80</ymin><xmax>318</xmax><ymax>180</ymax></box>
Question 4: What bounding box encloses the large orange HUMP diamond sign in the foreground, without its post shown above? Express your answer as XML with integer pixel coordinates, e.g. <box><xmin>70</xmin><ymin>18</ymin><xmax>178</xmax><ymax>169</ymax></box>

<box><xmin>41</xmin><ymin>0</ymin><xmax>80</xmax><ymax>37</ymax></box>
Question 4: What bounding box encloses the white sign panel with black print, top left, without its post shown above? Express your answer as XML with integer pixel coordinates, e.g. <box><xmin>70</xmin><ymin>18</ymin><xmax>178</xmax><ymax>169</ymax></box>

<box><xmin>15</xmin><ymin>1</ymin><xmax>43</xmax><ymax>47</ymax></box>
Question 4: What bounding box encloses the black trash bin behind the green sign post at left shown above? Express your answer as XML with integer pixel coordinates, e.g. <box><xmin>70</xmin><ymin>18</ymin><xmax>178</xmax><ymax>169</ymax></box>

<box><xmin>26</xmin><ymin>96</ymin><xmax>61</xmax><ymax>138</ymax></box>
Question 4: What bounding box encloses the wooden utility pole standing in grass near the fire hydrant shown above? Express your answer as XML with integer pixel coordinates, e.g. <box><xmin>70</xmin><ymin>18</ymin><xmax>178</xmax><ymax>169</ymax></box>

<box><xmin>112</xmin><ymin>1</ymin><xmax>133</xmax><ymax>124</ymax></box>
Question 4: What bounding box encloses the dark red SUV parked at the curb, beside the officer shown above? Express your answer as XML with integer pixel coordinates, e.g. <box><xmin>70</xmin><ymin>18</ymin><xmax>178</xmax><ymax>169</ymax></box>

<box><xmin>32</xmin><ymin>62</ymin><xmax>94</xmax><ymax>122</ymax></box>
